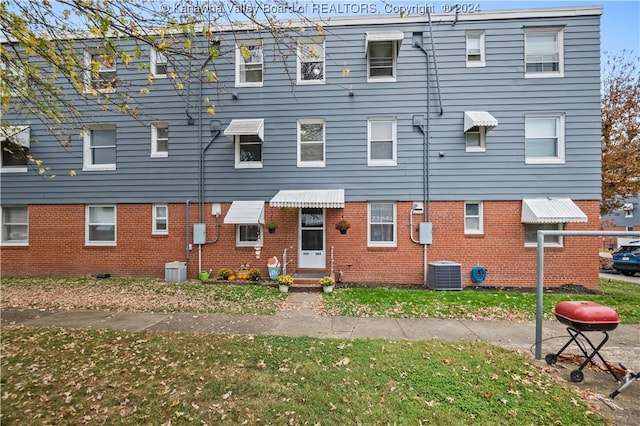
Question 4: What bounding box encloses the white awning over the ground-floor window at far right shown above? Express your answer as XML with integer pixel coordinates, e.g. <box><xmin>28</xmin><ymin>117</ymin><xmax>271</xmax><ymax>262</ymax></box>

<box><xmin>522</xmin><ymin>198</ymin><xmax>587</xmax><ymax>223</ymax></box>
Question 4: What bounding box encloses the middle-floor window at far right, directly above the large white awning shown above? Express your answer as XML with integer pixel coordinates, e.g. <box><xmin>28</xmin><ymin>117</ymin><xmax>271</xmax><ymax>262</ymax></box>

<box><xmin>524</xmin><ymin>114</ymin><xmax>564</xmax><ymax>164</ymax></box>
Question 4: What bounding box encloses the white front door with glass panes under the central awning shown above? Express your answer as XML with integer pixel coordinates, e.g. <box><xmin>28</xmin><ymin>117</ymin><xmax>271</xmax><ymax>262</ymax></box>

<box><xmin>298</xmin><ymin>208</ymin><xmax>325</xmax><ymax>269</ymax></box>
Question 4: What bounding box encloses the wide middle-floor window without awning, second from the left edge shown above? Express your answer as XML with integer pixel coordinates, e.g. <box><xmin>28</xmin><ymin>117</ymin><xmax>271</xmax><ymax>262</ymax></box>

<box><xmin>82</xmin><ymin>125</ymin><xmax>116</xmax><ymax>170</ymax></box>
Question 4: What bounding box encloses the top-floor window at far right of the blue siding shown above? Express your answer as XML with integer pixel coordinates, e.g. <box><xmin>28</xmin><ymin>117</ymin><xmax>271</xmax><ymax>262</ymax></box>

<box><xmin>524</xmin><ymin>28</ymin><xmax>564</xmax><ymax>77</ymax></box>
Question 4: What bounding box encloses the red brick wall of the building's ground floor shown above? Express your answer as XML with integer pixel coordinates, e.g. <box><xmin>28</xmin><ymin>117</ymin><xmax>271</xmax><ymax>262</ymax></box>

<box><xmin>1</xmin><ymin>201</ymin><xmax>601</xmax><ymax>288</ymax></box>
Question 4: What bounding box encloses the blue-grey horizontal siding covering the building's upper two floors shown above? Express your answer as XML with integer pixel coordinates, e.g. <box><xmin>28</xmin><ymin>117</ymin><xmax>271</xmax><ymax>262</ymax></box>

<box><xmin>1</xmin><ymin>9</ymin><xmax>600</xmax><ymax>204</ymax></box>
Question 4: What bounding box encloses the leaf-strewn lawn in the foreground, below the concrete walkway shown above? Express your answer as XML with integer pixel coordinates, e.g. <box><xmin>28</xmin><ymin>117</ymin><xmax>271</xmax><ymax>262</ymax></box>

<box><xmin>0</xmin><ymin>328</ymin><xmax>607</xmax><ymax>426</ymax></box>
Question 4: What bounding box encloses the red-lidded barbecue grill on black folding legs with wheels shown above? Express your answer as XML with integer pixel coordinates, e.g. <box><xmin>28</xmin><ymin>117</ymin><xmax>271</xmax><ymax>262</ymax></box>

<box><xmin>544</xmin><ymin>301</ymin><xmax>620</xmax><ymax>383</ymax></box>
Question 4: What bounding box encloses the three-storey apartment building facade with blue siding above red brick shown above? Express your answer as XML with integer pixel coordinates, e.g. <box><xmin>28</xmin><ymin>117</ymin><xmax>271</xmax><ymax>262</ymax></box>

<box><xmin>0</xmin><ymin>7</ymin><xmax>602</xmax><ymax>287</ymax></box>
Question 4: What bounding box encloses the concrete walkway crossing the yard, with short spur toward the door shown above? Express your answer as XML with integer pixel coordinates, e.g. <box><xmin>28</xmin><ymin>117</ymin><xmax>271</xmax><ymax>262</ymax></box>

<box><xmin>0</xmin><ymin>292</ymin><xmax>640</xmax><ymax>371</ymax></box>
